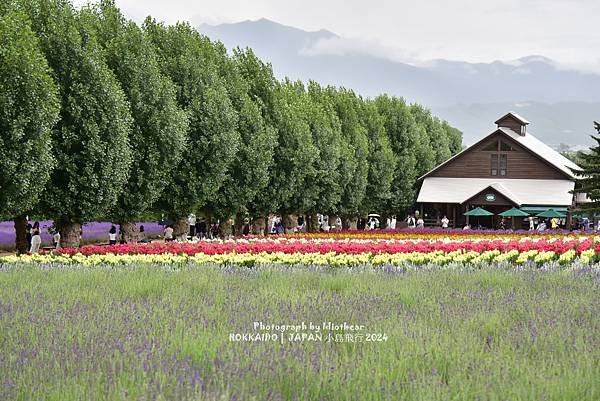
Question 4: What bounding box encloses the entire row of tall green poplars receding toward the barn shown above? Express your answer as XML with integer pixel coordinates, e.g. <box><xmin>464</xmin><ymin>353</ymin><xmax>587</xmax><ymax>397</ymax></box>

<box><xmin>0</xmin><ymin>0</ymin><xmax>461</xmax><ymax>250</ymax></box>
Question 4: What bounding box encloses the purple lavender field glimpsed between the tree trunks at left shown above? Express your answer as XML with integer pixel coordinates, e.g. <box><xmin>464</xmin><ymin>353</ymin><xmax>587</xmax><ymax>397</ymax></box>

<box><xmin>0</xmin><ymin>220</ymin><xmax>163</xmax><ymax>249</ymax></box>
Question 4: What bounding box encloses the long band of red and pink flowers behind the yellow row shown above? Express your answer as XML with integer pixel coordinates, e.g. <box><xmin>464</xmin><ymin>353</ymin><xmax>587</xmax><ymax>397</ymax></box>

<box><xmin>45</xmin><ymin>237</ymin><xmax>600</xmax><ymax>256</ymax></box>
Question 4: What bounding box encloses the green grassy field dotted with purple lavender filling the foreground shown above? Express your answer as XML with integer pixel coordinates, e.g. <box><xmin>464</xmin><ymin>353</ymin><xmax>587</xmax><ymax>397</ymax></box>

<box><xmin>0</xmin><ymin>266</ymin><xmax>600</xmax><ymax>401</ymax></box>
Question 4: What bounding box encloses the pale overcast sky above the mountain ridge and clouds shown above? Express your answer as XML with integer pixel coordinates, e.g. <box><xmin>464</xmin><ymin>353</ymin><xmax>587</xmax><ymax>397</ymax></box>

<box><xmin>74</xmin><ymin>0</ymin><xmax>600</xmax><ymax>71</ymax></box>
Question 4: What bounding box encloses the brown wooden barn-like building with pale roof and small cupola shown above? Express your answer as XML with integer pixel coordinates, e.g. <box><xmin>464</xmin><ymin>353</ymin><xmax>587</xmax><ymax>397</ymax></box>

<box><xmin>417</xmin><ymin>112</ymin><xmax>579</xmax><ymax>228</ymax></box>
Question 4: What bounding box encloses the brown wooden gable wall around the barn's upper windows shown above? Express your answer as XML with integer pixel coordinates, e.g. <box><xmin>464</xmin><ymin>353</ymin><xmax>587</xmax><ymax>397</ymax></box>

<box><xmin>429</xmin><ymin>133</ymin><xmax>565</xmax><ymax>179</ymax></box>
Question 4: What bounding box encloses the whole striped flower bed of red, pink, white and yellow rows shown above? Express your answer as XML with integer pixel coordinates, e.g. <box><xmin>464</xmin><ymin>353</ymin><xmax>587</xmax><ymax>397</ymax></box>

<box><xmin>0</xmin><ymin>232</ymin><xmax>600</xmax><ymax>266</ymax></box>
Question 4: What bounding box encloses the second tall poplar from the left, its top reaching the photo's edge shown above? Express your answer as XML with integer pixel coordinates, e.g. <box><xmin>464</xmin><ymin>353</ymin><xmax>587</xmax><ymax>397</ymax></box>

<box><xmin>24</xmin><ymin>0</ymin><xmax>131</xmax><ymax>247</ymax></box>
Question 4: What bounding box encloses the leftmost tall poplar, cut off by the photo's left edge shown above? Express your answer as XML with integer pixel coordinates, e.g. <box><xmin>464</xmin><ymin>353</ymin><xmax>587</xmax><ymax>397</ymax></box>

<box><xmin>0</xmin><ymin>10</ymin><xmax>59</xmax><ymax>253</ymax></box>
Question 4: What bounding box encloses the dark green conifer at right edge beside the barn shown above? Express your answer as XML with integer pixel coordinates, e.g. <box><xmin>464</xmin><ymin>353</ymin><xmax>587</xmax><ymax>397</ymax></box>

<box><xmin>573</xmin><ymin>122</ymin><xmax>600</xmax><ymax>215</ymax></box>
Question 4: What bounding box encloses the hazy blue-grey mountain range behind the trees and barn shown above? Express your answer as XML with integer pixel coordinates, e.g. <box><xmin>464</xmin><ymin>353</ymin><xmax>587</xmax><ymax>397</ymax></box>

<box><xmin>199</xmin><ymin>19</ymin><xmax>600</xmax><ymax>146</ymax></box>
